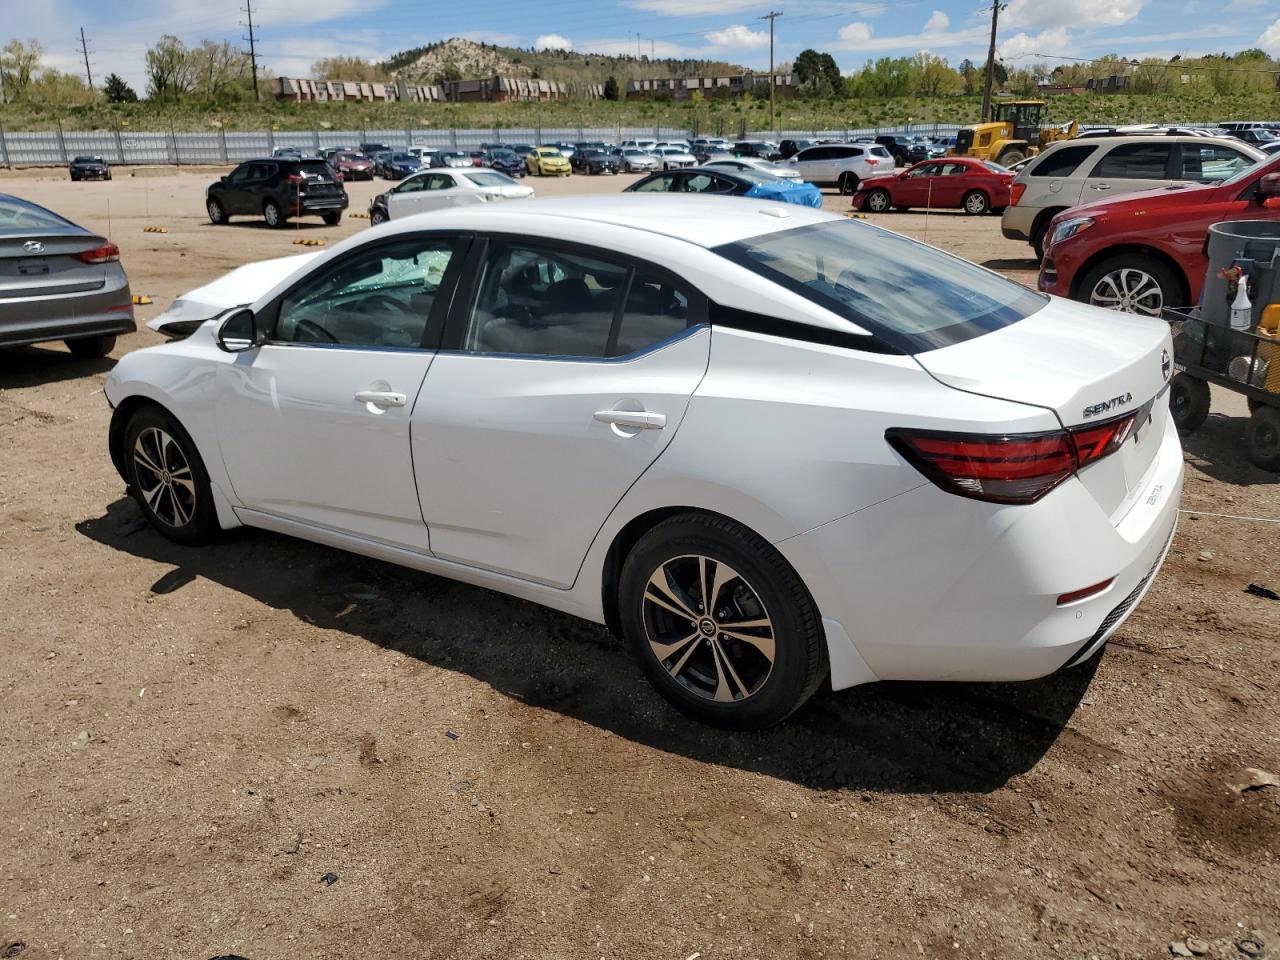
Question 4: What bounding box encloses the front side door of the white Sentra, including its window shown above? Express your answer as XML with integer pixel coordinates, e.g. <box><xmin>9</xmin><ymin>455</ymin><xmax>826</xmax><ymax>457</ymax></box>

<box><xmin>216</xmin><ymin>234</ymin><xmax>468</xmax><ymax>553</ymax></box>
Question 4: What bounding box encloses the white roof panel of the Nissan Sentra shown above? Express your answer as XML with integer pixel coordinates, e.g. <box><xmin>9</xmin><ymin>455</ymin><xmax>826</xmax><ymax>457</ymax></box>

<box><xmin>379</xmin><ymin>193</ymin><xmax>844</xmax><ymax>247</ymax></box>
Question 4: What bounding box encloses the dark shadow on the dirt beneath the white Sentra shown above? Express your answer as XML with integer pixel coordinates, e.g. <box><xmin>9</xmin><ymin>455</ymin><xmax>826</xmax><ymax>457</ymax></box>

<box><xmin>77</xmin><ymin>498</ymin><xmax>1097</xmax><ymax>794</ymax></box>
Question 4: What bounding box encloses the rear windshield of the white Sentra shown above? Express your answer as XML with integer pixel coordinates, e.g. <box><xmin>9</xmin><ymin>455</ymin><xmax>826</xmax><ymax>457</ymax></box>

<box><xmin>716</xmin><ymin>220</ymin><xmax>1048</xmax><ymax>353</ymax></box>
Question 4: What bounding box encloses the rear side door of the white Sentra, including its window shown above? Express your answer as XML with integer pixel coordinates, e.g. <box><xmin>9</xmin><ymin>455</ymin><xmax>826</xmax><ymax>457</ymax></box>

<box><xmin>412</xmin><ymin>237</ymin><xmax>710</xmax><ymax>588</ymax></box>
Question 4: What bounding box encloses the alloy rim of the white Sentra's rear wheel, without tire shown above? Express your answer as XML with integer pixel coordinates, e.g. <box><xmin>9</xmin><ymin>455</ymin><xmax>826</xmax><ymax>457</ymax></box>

<box><xmin>641</xmin><ymin>556</ymin><xmax>776</xmax><ymax>703</ymax></box>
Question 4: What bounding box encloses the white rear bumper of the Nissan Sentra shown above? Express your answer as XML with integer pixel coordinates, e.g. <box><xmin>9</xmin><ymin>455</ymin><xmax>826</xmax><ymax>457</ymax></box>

<box><xmin>776</xmin><ymin>419</ymin><xmax>1183</xmax><ymax>687</ymax></box>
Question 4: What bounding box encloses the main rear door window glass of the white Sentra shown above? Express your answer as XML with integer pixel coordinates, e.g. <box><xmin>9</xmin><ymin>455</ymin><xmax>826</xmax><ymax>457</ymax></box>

<box><xmin>463</xmin><ymin>243</ymin><xmax>628</xmax><ymax>357</ymax></box>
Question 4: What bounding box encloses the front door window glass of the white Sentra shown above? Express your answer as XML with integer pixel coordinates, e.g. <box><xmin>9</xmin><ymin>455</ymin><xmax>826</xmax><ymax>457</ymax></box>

<box><xmin>274</xmin><ymin>237</ymin><xmax>454</xmax><ymax>348</ymax></box>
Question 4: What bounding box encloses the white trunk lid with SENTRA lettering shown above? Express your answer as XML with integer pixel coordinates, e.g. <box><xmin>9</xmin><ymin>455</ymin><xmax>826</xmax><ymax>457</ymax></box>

<box><xmin>915</xmin><ymin>298</ymin><xmax>1174</xmax><ymax>522</ymax></box>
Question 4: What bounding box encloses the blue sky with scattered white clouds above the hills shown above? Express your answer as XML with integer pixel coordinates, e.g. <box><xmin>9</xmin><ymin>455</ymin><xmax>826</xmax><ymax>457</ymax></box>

<box><xmin>10</xmin><ymin>0</ymin><xmax>1280</xmax><ymax>92</ymax></box>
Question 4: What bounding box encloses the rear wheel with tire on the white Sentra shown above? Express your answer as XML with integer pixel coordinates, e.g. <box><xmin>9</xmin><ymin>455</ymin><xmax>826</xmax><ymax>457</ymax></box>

<box><xmin>618</xmin><ymin>513</ymin><xmax>828</xmax><ymax>730</ymax></box>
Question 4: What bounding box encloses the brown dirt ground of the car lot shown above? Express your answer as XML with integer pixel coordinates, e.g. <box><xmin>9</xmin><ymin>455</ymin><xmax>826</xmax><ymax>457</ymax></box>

<box><xmin>0</xmin><ymin>170</ymin><xmax>1280</xmax><ymax>960</ymax></box>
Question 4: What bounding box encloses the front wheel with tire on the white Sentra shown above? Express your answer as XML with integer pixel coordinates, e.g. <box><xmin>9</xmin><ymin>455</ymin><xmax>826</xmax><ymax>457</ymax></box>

<box><xmin>122</xmin><ymin>406</ymin><xmax>218</xmax><ymax>545</ymax></box>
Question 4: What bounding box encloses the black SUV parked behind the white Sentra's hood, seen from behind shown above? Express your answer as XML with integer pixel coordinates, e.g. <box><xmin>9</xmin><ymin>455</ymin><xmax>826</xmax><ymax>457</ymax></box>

<box><xmin>205</xmin><ymin>156</ymin><xmax>348</xmax><ymax>227</ymax></box>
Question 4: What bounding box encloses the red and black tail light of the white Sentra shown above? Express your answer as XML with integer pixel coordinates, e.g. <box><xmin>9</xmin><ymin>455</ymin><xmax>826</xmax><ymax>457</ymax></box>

<box><xmin>884</xmin><ymin>412</ymin><xmax>1142</xmax><ymax>503</ymax></box>
